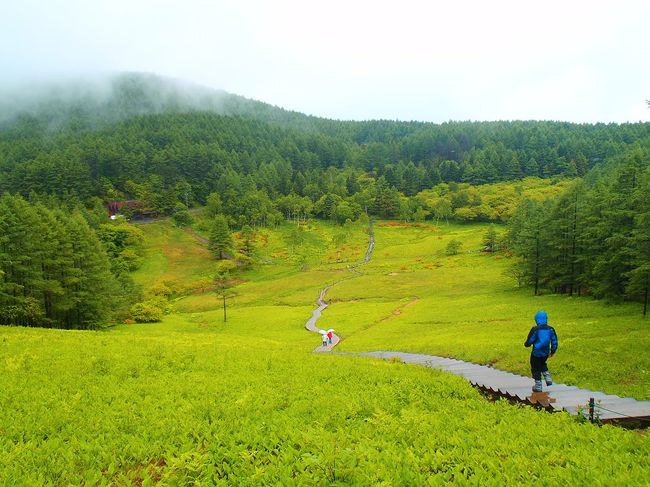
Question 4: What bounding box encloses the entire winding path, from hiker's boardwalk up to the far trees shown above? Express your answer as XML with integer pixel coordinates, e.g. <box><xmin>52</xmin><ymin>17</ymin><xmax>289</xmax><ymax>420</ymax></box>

<box><xmin>305</xmin><ymin>222</ymin><xmax>650</xmax><ymax>423</ymax></box>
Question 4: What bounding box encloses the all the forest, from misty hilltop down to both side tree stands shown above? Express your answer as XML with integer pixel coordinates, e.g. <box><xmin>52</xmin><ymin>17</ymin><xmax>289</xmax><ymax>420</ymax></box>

<box><xmin>0</xmin><ymin>74</ymin><xmax>650</xmax><ymax>328</ymax></box>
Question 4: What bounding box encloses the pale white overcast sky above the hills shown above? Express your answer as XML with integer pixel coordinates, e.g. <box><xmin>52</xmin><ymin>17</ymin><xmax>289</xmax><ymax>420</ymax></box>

<box><xmin>0</xmin><ymin>0</ymin><xmax>650</xmax><ymax>122</ymax></box>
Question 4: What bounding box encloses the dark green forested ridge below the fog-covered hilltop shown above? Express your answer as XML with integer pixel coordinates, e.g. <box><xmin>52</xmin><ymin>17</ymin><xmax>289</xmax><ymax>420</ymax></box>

<box><xmin>0</xmin><ymin>112</ymin><xmax>650</xmax><ymax>212</ymax></box>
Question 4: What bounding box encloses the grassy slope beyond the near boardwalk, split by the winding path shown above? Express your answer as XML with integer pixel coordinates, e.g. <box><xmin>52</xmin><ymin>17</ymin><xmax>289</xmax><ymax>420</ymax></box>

<box><xmin>136</xmin><ymin>217</ymin><xmax>650</xmax><ymax>399</ymax></box>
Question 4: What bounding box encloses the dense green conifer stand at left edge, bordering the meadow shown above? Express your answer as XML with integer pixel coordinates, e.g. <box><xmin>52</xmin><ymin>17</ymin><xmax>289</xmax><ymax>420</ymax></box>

<box><xmin>0</xmin><ymin>194</ymin><xmax>137</xmax><ymax>329</ymax></box>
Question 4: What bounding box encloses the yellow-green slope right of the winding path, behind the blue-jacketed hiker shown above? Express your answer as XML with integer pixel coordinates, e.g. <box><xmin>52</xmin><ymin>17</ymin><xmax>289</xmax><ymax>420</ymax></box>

<box><xmin>326</xmin><ymin>223</ymin><xmax>650</xmax><ymax>399</ymax></box>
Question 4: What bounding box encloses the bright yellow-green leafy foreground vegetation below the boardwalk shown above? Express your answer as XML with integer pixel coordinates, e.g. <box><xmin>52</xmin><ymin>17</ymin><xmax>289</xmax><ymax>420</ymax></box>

<box><xmin>0</xmin><ymin>324</ymin><xmax>650</xmax><ymax>486</ymax></box>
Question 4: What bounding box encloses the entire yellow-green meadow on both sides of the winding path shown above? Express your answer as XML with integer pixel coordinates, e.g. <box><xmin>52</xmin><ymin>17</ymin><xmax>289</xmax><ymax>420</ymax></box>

<box><xmin>0</xmin><ymin>222</ymin><xmax>650</xmax><ymax>485</ymax></box>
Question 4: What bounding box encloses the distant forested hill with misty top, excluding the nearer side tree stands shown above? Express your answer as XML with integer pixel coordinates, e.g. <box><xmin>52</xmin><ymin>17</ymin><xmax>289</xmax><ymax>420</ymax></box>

<box><xmin>0</xmin><ymin>74</ymin><xmax>650</xmax><ymax>207</ymax></box>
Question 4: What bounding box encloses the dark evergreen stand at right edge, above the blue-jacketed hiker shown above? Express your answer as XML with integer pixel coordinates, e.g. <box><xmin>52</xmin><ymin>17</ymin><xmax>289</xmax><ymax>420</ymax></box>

<box><xmin>508</xmin><ymin>148</ymin><xmax>650</xmax><ymax>314</ymax></box>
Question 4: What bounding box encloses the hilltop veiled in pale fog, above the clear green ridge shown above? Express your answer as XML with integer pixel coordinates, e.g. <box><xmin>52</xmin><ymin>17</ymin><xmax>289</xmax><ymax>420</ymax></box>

<box><xmin>0</xmin><ymin>73</ymin><xmax>314</xmax><ymax>129</ymax></box>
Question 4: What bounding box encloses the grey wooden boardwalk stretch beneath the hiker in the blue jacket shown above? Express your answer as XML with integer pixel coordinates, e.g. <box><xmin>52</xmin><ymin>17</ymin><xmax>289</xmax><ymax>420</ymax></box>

<box><xmin>357</xmin><ymin>351</ymin><xmax>650</xmax><ymax>423</ymax></box>
